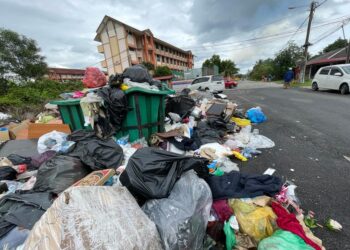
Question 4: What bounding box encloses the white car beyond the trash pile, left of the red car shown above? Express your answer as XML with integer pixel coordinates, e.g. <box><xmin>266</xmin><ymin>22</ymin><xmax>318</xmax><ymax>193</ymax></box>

<box><xmin>188</xmin><ymin>75</ymin><xmax>225</xmax><ymax>92</ymax></box>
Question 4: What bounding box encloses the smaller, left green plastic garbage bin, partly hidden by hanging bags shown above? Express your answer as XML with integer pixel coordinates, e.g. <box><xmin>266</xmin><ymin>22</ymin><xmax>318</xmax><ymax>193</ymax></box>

<box><xmin>50</xmin><ymin>99</ymin><xmax>87</xmax><ymax>131</ymax></box>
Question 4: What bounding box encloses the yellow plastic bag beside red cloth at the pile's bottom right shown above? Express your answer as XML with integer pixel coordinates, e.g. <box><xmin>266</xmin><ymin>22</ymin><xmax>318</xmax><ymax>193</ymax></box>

<box><xmin>229</xmin><ymin>199</ymin><xmax>277</xmax><ymax>242</ymax></box>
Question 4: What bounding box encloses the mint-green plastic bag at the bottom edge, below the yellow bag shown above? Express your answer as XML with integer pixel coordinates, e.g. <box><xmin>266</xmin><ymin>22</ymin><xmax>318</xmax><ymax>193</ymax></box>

<box><xmin>258</xmin><ymin>229</ymin><xmax>314</xmax><ymax>250</ymax></box>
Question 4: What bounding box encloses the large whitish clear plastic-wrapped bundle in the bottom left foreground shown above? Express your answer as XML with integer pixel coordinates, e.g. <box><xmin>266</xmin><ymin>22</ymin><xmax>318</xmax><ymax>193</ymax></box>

<box><xmin>24</xmin><ymin>186</ymin><xmax>162</xmax><ymax>250</ymax></box>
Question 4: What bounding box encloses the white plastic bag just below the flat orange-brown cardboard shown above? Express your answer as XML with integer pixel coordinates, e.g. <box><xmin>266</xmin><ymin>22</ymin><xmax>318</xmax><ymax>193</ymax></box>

<box><xmin>38</xmin><ymin>130</ymin><xmax>74</xmax><ymax>154</ymax></box>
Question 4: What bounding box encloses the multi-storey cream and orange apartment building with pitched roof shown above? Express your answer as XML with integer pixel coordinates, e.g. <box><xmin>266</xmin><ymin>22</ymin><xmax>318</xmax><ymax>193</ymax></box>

<box><xmin>94</xmin><ymin>16</ymin><xmax>193</xmax><ymax>75</ymax></box>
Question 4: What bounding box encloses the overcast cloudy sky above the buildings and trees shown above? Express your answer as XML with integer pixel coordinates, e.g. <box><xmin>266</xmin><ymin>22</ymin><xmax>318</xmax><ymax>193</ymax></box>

<box><xmin>0</xmin><ymin>0</ymin><xmax>350</xmax><ymax>73</ymax></box>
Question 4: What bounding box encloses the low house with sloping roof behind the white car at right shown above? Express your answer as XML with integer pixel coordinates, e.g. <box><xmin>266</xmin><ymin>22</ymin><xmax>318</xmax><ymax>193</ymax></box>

<box><xmin>305</xmin><ymin>47</ymin><xmax>347</xmax><ymax>79</ymax></box>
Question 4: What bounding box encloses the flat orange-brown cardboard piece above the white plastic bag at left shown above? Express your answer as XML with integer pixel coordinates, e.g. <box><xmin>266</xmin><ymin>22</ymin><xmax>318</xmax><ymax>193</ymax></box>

<box><xmin>28</xmin><ymin>123</ymin><xmax>71</xmax><ymax>139</ymax></box>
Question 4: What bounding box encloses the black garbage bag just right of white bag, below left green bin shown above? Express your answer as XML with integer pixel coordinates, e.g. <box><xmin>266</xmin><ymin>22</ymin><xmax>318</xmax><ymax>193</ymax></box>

<box><xmin>67</xmin><ymin>130</ymin><xmax>124</xmax><ymax>170</ymax></box>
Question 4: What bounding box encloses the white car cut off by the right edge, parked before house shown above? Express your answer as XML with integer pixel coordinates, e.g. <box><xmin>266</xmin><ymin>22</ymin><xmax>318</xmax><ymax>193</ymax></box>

<box><xmin>312</xmin><ymin>64</ymin><xmax>350</xmax><ymax>95</ymax></box>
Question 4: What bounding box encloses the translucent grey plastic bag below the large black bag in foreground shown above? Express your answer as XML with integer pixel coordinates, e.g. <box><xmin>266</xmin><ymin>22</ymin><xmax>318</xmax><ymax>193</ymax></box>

<box><xmin>142</xmin><ymin>171</ymin><xmax>212</xmax><ymax>249</ymax></box>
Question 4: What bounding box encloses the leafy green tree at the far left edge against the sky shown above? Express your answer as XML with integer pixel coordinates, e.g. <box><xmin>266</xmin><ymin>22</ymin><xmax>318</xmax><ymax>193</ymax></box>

<box><xmin>0</xmin><ymin>29</ymin><xmax>47</xmax><ymax>80</ymax></box>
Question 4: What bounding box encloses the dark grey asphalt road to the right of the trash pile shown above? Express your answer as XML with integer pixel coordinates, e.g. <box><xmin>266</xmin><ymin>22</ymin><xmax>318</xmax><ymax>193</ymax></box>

<box><xmin>225</xmin><ymin>81</ymin><xmax>350</xmax><ymax>250</ymax></box>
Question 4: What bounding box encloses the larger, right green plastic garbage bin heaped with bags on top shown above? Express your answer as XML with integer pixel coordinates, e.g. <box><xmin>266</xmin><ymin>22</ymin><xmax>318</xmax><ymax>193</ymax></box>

<box><xmin>116</xmin><ymin>87</ymin><xmax>175</xmax><ymax>142</ymax></box>
